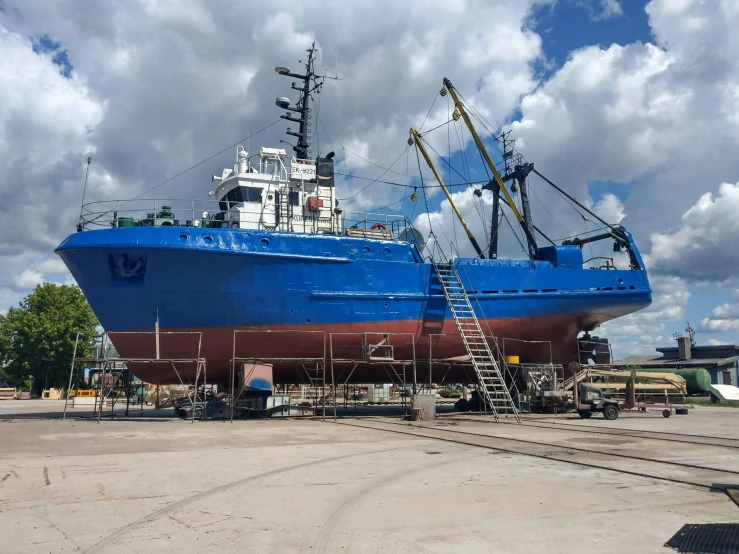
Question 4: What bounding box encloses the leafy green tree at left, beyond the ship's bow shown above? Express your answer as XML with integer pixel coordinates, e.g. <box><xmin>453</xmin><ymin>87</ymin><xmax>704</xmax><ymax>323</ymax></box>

<box><xmin>0</xmin><ymin>283</ymin><xmax>99</xmax><ymax>393</ymax></box>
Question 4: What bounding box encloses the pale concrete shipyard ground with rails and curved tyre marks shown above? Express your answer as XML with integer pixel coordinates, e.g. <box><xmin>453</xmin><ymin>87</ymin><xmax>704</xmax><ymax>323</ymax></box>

<box><xmin>0</xmin><ymin>401</ymin><xmax>739</xmax><ymax>554</ymax></box>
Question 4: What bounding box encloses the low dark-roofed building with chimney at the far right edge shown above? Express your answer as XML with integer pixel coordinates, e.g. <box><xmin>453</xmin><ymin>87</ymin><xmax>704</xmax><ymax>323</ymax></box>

<box><xmin>613</xmin><ymin>337</ymin><xmax>739</xmax><ymax>386</ymax></box>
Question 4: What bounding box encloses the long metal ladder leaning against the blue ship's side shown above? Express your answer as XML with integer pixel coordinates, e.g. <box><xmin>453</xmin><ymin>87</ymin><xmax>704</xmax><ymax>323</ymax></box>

<box><xmin>433</xmin><ymin>262</ymin><xmax>521</xmax><ymax>423</ymax></box>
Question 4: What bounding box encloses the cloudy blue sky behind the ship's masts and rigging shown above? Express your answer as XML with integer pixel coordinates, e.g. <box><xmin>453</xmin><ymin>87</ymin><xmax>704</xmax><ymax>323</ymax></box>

<box><xmin>0</xmin><ymin>0</ymin><xmax>739</xmax><ymax>357</ymax></box>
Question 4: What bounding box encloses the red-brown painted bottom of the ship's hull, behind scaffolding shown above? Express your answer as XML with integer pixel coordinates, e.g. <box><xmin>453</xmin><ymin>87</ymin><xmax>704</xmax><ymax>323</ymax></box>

<box><xmin>110</xmin><ymin>314</ymin><xmax>609</xmax><ymax>384</ymax></box>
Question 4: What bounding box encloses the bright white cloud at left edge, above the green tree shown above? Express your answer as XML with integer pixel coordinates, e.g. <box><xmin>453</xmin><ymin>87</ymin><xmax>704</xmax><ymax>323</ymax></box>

<box><xmin>0</xmin><ymin>25</ymin><xmax>106</xmax><ymax>311</ymax></box>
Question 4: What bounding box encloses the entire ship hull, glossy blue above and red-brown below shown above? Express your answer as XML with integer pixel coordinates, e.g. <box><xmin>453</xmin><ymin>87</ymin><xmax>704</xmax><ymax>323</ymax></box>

<box><xmin>56</xmin><ymin>227</ymin><xmax>651</xmax><ymax>383</ymax></box>
